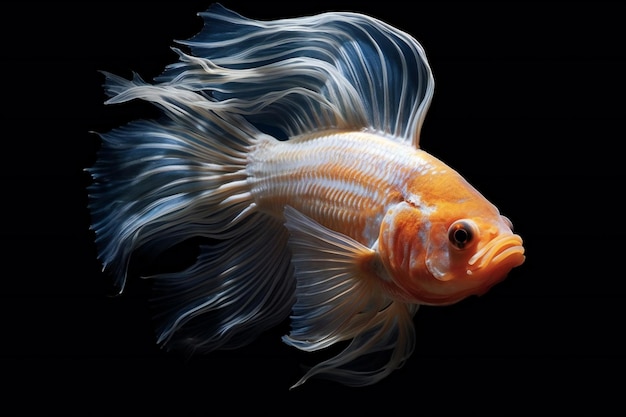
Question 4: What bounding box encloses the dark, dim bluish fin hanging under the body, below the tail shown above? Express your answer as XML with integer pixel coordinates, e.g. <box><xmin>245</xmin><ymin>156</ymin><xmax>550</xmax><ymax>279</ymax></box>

<box><xmin>149</xmin><ymin>214</ymin><xmax>295</xmax><ymax>353</ymax></box>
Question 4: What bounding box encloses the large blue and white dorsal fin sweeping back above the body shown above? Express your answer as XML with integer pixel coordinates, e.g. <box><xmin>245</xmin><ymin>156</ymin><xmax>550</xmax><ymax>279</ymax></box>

<box><xmin>157</xmin><ymin>4</ymin><xmax>434</xmax><ymax>147</ymax></box>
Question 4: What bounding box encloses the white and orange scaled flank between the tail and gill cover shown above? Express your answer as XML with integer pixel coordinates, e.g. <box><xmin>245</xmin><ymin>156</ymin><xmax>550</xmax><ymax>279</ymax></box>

<box><xmin>248</xmin><ymin>132</ymin><xmax>420</xmax><ymax>247</ymax></box>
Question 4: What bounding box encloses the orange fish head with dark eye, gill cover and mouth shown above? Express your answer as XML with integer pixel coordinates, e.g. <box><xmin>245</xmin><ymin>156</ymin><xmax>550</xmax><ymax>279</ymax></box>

<box><xmin>378</xmin><ymin>198</ymin><xmax>525</xmax><ymax>305</ymax></box>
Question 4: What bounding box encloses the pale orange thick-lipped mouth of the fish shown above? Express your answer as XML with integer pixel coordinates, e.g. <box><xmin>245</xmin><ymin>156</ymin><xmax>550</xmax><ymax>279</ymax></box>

<box><xmin>467</xmin><ymin>235</ymin><xmax>526</xmax><ymax>274</ymax></box>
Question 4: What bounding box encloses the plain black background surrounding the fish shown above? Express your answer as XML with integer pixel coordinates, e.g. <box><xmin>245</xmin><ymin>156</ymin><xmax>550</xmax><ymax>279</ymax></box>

<box><xmin>0</xmin><ymin>0</ymin><xmax>626</xmax><ymax>416</ymax></box>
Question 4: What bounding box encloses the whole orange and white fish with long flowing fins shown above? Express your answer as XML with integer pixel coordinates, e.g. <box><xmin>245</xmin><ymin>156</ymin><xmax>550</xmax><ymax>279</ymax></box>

<box><xmin>89</xmin><ymin>4</ymin><xmax>524</xmax><ymax>386</ymax></box>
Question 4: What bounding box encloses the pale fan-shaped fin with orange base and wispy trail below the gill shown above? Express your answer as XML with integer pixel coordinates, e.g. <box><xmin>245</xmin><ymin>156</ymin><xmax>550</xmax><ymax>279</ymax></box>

<box><xmin>283</xmin><ymin>207</ymin><xmax>417</xmax><ymax>387</ymax></box>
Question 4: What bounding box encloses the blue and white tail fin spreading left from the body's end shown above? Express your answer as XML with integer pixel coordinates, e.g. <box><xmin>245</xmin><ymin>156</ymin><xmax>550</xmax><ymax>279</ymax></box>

<box><xmin>88</xmin><ymin>74</ymin><xmax>260</xmax><ymax>292</ymax></box>
